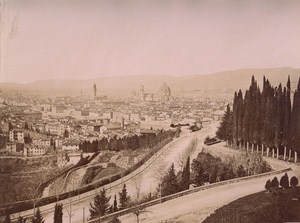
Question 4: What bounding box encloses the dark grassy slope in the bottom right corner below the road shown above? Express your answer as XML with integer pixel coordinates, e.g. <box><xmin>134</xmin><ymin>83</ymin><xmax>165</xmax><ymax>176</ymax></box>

<box><xmin>204</xmin><ymin>187</ymin><xmax>300</xmax><ymax>223</ymax></box>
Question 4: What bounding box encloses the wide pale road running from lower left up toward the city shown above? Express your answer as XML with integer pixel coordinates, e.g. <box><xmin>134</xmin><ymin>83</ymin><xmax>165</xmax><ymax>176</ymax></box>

<box><xmin>14</xmin><ymin>126</ymin><xmax>211</xmax><ymax>223</ymax></box>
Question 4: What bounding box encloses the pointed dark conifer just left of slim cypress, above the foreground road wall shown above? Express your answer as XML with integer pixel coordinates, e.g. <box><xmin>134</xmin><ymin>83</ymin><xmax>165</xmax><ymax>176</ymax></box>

<box><xmin>161</xmin><ymin>163</ymin><xmax>180</xmax><ymax>196</ymax></box>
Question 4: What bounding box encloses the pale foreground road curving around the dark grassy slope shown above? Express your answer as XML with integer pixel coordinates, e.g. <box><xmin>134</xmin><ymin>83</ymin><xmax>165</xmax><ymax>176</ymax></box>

<box><xmin>119</xmin><ymin>149</ymin><xmax>300</xmax><ymax>223</ymax></box>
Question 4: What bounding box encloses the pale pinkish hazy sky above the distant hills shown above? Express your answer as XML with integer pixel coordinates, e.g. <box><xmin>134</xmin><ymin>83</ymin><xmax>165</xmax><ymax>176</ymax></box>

<box><xmin>0</xmin><ymin>0</ymin><xmax>300</xmax><ymax>83</ymax></box>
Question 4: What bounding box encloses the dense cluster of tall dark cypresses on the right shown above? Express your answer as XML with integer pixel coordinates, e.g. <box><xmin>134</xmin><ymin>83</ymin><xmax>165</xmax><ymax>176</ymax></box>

<box><xmin>216</xmin><ymin>77</ymin><xmax>300</xmax><ymax>150</ymax></box>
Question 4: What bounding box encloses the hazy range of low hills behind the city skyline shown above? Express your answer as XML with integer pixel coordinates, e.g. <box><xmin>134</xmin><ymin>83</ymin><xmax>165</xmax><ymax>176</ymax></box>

<box><xmin>0</xmin><ymin>67</ymin><xmax>300</xmax><ymax>95</ymax></box>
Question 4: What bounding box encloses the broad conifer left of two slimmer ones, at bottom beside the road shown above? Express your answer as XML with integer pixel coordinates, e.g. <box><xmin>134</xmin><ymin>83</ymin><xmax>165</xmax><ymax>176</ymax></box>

<box><xmin>90</xmin><ymin>188</ymin><xmax>110</xmax><ymax>219</ymax></box>
